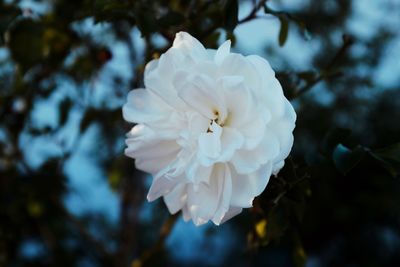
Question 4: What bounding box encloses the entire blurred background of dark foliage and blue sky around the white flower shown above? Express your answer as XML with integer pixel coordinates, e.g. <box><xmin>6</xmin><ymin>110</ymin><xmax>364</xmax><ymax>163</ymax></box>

<box><xmin>0</xmin><ymin>0</ymin><xmax>400</xmax><ymax>267</ymax></box>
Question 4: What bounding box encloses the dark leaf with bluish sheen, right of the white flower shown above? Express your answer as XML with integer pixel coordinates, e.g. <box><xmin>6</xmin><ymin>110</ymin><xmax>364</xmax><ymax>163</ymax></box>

<box><xmin>332</xmin><ymin>144</ymin><xmax>365</xmax><ymax>175</ymax></box>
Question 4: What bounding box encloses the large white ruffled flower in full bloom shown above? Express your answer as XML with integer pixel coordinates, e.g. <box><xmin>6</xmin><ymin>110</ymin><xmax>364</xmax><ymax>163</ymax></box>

<box><xmin>123</xmin><ymin>32</ymin><xmax>296</xmax><ymax>225</ymax></box>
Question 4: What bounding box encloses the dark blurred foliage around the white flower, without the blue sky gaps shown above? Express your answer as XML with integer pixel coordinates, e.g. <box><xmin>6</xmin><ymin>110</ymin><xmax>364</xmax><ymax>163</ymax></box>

<box><xmin>0</xmin><ymin>0</ymin><xmax>400</xmax><ymax>267</ymax></box>
